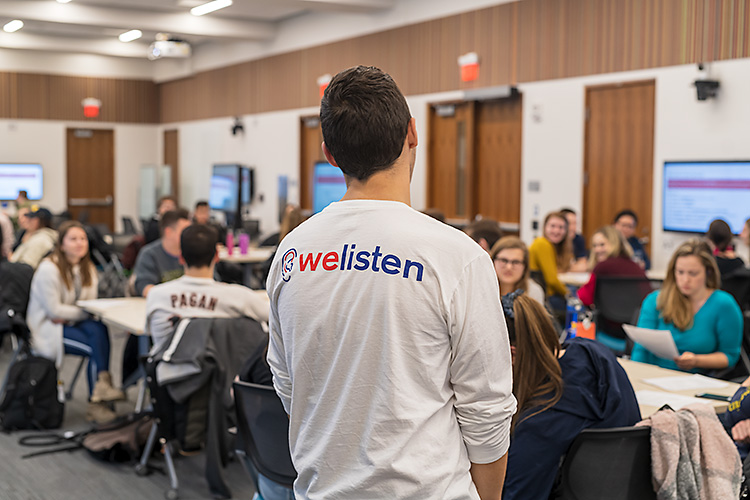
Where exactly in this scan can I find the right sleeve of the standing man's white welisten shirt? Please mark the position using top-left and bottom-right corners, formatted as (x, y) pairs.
(450, 254), (516, 464)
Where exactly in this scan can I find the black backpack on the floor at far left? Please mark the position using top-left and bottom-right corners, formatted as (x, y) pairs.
(0, 342), (65, 431)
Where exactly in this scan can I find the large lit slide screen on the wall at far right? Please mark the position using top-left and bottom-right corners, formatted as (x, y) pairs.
(662, 161), (750, 234)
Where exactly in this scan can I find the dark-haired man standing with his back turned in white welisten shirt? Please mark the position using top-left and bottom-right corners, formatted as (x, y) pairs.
(267, 66), (516, 500)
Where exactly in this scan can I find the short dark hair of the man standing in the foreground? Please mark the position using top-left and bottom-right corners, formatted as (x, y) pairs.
(320, 66), (411, 181)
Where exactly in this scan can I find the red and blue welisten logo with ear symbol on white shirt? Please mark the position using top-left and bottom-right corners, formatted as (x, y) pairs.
(281, 243), (424, 282)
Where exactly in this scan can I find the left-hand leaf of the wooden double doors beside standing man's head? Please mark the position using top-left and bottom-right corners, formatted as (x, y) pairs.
(427, 102), (476, 220)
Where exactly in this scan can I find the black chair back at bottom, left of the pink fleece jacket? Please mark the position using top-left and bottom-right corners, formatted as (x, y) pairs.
(550, 427), (656, 500)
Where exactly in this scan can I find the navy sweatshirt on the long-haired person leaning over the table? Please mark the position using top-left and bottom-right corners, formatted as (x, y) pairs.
(503, 338), (641, 500)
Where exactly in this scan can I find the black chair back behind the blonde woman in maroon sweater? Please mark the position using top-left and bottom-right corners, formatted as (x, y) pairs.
(594, 276), (658, 339)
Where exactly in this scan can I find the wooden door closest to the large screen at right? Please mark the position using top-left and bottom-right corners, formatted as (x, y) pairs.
(583, 80), (654, 256)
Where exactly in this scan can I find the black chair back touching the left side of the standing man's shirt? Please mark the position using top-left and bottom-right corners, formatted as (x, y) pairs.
(234, 382), (297, 488)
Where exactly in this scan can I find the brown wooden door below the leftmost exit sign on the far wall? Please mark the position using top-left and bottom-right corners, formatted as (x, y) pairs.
(67, 128), (115, 231)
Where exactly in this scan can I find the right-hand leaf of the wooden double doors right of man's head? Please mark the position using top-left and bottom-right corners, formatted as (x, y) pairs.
(474, 95), (522, 224)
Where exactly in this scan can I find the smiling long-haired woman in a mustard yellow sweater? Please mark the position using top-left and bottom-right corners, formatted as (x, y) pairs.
(529, 212), (572, 311)
